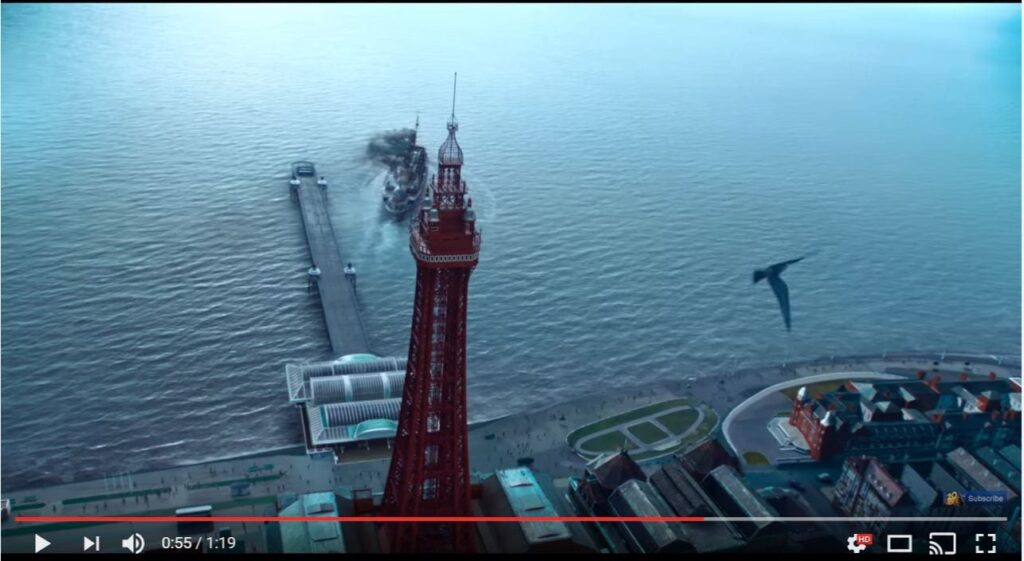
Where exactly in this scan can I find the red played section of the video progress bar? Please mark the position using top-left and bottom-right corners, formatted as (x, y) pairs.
(14, 516), (705, 522)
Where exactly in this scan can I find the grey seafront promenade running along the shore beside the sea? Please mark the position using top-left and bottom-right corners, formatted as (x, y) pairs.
(3, 353), (1021, 552)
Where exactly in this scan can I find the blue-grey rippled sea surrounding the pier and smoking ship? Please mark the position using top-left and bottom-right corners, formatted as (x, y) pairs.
(0, 4), (1021, 490)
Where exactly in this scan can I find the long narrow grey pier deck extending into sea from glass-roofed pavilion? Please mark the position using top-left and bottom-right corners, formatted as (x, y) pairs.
(294, 162), (370, 355)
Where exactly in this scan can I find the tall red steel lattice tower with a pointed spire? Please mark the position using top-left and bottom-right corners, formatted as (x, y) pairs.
(381, 75), (480, 553)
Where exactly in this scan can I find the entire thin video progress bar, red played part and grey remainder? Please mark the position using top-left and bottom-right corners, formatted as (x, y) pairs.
(14, 516), (1007, 523)
